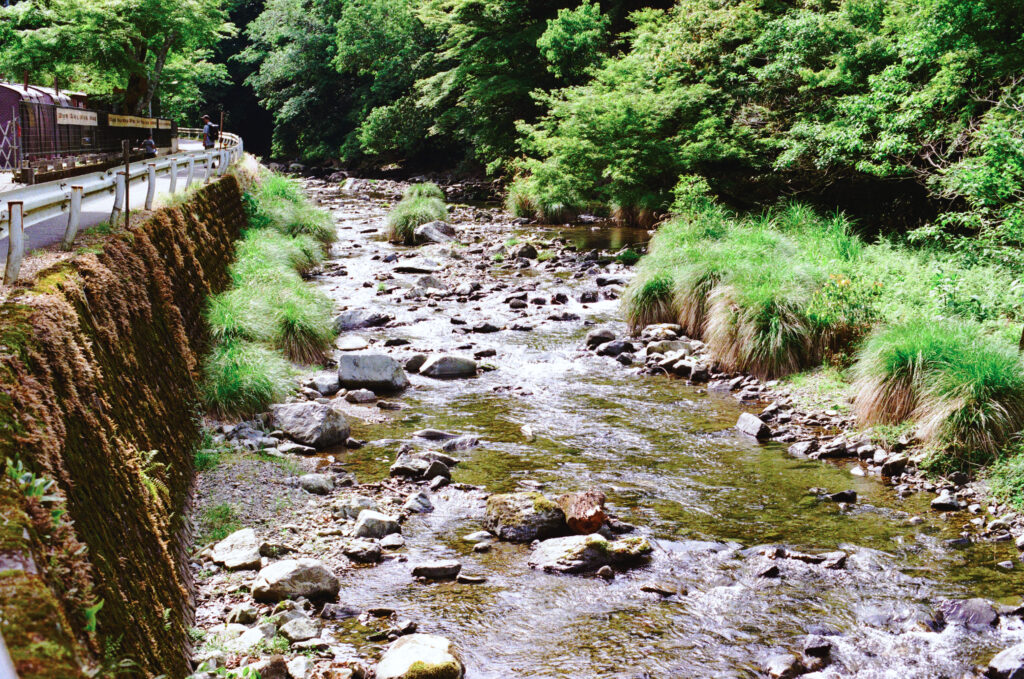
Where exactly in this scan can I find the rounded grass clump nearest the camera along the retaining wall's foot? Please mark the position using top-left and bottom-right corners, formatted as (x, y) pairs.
(203, 339), (293, 417)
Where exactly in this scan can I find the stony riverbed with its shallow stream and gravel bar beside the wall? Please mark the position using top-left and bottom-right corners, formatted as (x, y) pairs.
(194, 180), (1024, 679)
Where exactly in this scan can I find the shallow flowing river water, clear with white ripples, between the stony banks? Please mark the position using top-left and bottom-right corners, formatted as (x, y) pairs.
(307, 182), (1024, 679)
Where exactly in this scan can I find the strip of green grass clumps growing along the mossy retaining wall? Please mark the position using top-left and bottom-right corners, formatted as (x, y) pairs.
(204, 172), (334, 415)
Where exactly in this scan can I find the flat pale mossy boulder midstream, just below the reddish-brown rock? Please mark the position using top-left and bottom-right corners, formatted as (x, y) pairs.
(528, 534), (653, 572)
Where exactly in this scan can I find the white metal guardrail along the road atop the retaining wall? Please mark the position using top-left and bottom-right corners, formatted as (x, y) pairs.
(0, 128), (243, 285)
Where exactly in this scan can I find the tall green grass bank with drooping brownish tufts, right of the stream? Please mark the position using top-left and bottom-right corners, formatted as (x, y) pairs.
(625, 179), (1024, 477)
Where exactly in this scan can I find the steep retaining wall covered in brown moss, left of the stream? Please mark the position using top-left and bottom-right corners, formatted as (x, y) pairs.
(0, 176), (245, 679)
